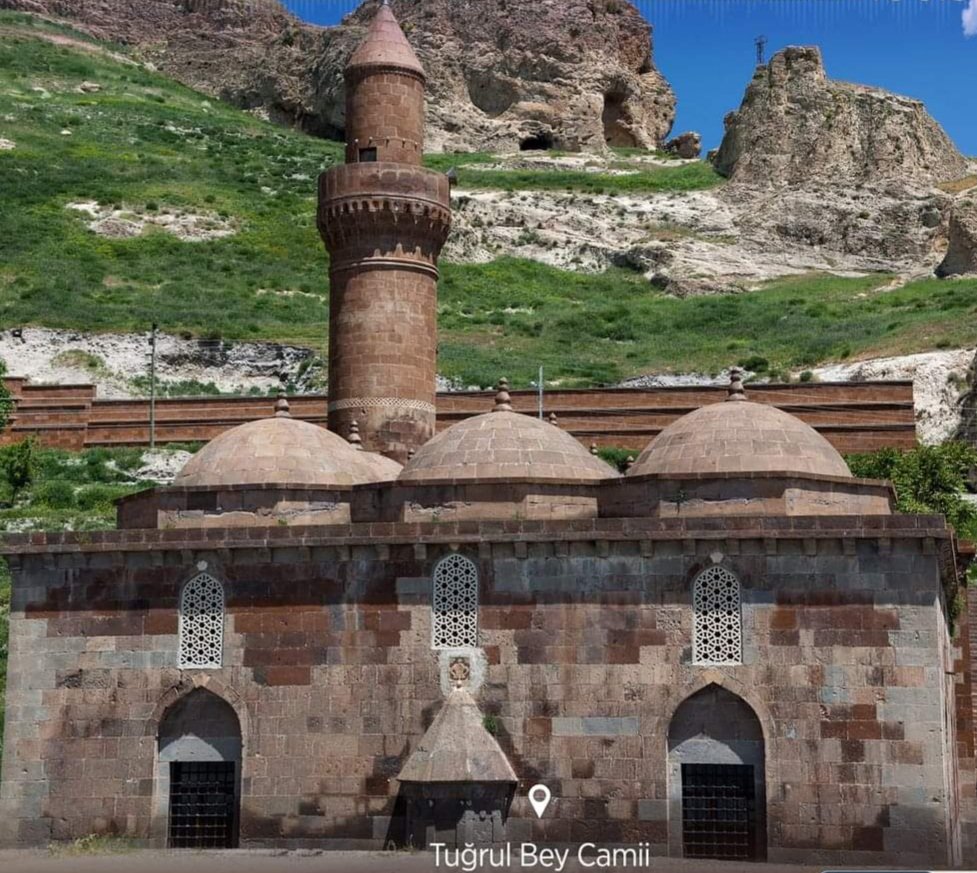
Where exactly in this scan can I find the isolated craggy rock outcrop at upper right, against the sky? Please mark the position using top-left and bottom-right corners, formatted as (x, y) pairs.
(715, 46), (967, 187)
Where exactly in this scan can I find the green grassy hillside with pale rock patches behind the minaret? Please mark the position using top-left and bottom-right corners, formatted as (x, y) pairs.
(0, 10), (977, 433)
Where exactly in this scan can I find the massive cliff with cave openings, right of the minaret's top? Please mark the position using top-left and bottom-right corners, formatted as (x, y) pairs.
(332, 0), (675, 152)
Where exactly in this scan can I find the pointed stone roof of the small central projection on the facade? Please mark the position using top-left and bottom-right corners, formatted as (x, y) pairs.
(397, 688), (518, 782)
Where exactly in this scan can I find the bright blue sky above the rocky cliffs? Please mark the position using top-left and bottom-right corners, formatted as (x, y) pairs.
(283, 0), (977, 156)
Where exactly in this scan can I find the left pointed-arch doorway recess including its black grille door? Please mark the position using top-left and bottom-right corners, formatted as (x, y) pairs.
(157, 688), (241, 849)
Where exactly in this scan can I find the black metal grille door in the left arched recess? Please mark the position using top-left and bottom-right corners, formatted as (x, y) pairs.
(169, 761), (237, 849)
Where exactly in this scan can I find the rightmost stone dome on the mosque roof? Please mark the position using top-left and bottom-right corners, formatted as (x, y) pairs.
(628, 401), (851, 478)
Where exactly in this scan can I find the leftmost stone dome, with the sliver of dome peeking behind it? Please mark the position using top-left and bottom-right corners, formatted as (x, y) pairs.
(173, 416), (400, 487)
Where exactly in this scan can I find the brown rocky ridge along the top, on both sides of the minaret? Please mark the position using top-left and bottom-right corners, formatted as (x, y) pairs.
(0, 0), (675, 152)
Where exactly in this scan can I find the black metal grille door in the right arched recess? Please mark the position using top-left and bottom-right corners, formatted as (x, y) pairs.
(682, 764), (757, 861)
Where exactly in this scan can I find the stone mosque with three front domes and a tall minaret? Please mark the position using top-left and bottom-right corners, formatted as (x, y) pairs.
(0, 6), (977, 867)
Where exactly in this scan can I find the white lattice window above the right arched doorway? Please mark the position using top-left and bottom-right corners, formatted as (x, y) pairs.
(692, 567), (743, 664)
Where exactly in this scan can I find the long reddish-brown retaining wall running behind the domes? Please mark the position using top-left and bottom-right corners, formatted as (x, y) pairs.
(0, 379), (916, 453)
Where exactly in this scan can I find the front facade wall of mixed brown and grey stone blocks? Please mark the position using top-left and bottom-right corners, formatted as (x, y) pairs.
(0, 528), (960, 866)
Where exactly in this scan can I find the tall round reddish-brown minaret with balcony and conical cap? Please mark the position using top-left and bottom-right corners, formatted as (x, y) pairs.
(319, 4), (451, 463)
